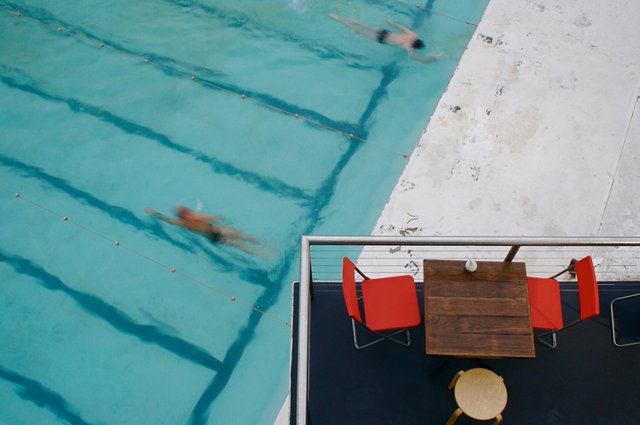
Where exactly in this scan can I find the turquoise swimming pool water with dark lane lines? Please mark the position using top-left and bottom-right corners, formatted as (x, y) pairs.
(0, 0), (486, 424)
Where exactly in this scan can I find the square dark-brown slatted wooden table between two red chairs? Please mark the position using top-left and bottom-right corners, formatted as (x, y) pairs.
(424, 260), (535, 358)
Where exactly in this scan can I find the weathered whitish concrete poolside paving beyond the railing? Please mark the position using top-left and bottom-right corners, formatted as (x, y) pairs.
(373, 0), (640, 240)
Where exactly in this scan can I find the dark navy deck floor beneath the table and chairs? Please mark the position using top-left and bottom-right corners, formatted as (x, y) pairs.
(298, 283), (640, 425)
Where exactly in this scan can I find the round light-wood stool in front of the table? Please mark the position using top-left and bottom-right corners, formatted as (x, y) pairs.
(446, 368), (507, 425)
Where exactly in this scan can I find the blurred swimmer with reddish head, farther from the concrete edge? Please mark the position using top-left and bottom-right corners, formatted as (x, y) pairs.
(145, 205), (262, 256)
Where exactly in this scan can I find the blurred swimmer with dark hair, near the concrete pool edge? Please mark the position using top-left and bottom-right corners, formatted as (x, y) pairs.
(329, 13), (444, 63)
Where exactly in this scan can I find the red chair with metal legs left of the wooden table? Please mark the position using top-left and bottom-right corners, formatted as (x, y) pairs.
(342, 257), (421, 349)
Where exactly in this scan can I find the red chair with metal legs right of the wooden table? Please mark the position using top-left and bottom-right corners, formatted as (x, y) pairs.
(527, 256), (600, 348)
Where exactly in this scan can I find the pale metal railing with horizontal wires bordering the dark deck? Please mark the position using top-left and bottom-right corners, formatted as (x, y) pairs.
(291, 236), (640, 425)
